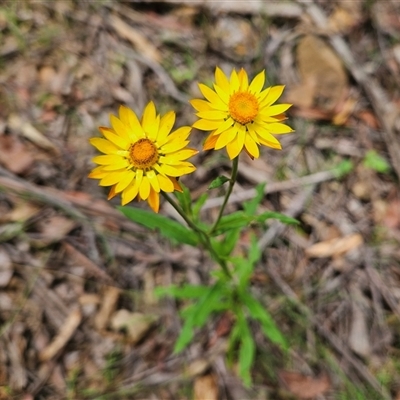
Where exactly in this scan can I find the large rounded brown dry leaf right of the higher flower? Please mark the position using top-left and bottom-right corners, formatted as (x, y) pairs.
(286, 35), (348, 114)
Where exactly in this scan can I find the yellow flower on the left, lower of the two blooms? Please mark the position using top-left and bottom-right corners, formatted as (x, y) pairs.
(89, 102), (198, 212)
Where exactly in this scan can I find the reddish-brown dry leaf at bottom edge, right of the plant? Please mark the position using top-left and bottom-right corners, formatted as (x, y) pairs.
(279, 371), (331, 399)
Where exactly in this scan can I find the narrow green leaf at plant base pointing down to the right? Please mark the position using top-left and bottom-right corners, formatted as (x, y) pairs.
(241, 292), (288, 350)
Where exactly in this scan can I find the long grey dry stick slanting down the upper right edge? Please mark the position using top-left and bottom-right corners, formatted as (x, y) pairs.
(297, 0), (400, 179)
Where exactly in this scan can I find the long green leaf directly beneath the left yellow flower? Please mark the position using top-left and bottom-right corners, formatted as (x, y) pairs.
(118, 206), (199, 246)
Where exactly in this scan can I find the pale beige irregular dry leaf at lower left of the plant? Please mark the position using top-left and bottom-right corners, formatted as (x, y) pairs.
(110, 309), (158, 344)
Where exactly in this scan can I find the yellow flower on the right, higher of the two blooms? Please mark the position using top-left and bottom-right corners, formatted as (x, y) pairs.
(191, 67), (293, 160)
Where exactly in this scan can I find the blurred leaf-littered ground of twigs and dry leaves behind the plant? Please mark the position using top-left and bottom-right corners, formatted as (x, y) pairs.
(0, 0), (400, 400)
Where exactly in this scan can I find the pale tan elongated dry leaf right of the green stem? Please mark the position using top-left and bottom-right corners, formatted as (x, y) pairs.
(305, 233), (364, 258)
